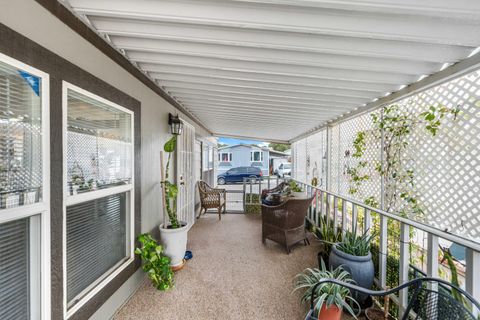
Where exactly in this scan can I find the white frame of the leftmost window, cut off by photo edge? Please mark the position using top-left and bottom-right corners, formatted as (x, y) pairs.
(0, 53), (51, 320)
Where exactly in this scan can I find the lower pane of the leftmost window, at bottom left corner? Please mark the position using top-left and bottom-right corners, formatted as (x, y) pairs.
(0, 219), (30, 320)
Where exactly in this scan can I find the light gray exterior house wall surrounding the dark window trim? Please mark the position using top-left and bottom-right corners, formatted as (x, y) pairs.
(0, 0), (209, 319)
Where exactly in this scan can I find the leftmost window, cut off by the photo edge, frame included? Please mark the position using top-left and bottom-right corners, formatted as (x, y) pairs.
(0, 54), (51, 320)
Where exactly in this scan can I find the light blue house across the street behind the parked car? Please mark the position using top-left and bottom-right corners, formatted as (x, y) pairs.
(218, 144), (270, 175)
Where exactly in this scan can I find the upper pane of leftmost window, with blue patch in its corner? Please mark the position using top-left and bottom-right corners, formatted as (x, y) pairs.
(0, 62), (42, 208)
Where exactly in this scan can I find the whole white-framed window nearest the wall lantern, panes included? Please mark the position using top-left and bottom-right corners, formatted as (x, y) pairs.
(63, 82), (134, 317)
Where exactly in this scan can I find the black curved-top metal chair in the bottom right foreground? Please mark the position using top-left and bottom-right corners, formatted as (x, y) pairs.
(305, 278), (480, 320)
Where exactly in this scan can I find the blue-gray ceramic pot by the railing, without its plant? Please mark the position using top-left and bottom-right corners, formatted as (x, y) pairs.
(328, 244), (375, 304)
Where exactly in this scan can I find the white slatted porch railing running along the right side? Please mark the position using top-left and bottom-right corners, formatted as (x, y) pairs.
(296, 180), (480, 315)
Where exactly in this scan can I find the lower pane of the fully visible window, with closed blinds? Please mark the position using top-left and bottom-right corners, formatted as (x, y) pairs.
(67, 193), (128, 306)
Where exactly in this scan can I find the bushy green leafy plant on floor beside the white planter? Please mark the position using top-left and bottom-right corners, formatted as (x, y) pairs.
(135, 233), (174, 291)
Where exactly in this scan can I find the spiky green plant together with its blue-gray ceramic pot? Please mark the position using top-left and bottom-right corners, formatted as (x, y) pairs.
(329, 230), (375, 304)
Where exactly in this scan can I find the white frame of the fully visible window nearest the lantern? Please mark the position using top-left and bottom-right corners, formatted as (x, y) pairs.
(62, 81), (135, 319)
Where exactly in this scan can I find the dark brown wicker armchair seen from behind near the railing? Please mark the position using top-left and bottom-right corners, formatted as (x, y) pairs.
(262, 197), (313, 253)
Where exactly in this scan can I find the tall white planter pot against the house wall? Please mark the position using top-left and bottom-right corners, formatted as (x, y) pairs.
(160, 221), (188, 267)
